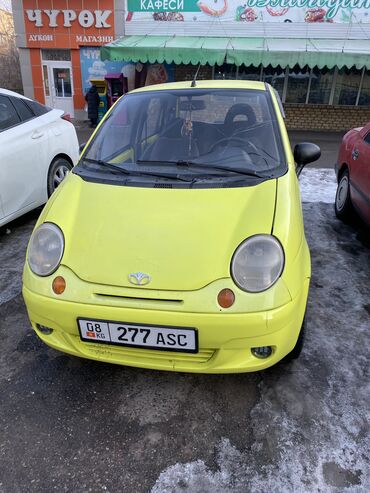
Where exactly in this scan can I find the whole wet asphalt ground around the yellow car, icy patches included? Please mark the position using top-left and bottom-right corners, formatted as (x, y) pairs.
(0, 135), (370, 493)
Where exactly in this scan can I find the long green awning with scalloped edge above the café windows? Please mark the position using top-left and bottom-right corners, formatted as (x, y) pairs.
(100, 36), (370, 69)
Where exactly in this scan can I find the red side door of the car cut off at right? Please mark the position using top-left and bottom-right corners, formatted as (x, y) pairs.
(350, 124), (370, 223)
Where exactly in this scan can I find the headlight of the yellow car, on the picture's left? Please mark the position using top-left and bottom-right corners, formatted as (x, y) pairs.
(28, 223), (64, 276)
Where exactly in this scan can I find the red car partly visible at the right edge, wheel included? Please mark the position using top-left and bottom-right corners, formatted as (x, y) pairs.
(335, 123), (370, 225)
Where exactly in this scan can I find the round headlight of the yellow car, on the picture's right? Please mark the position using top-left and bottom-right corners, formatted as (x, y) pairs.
(231, 235), (284, 293)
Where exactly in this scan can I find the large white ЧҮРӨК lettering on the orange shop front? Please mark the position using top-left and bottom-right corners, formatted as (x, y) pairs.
(26, 9), (112, 29)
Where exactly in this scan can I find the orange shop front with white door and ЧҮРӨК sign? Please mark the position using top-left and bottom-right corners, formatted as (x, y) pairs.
(12, 0), (123, 118)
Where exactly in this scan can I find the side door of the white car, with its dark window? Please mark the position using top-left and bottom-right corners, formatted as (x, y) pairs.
(0, 94), (47, 217)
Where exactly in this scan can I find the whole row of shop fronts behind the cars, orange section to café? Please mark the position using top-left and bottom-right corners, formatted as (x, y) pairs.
(13, 0), (370, 130)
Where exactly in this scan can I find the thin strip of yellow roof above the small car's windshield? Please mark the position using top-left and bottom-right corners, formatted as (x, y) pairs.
(130, 80), (267, 93)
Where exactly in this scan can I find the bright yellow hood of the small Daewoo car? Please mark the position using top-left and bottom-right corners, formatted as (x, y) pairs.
(44, 174), (276, 291)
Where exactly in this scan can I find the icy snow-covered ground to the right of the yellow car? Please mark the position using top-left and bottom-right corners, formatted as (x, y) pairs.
(152, 169), (370, 493)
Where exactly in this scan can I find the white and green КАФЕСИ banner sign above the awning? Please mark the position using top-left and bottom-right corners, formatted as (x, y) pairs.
(126, 0), (370, 23)
